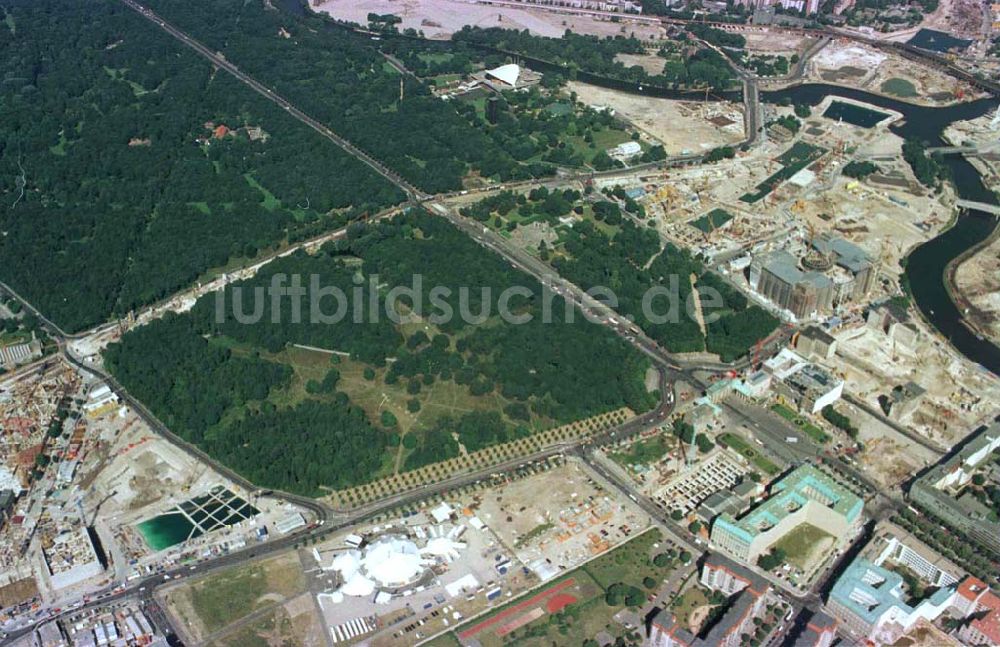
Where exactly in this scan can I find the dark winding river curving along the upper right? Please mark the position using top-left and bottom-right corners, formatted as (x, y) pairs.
(277, 0), (1000, 375)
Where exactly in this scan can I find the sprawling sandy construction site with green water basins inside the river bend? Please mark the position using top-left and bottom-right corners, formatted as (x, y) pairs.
(620, 97), (953, 316)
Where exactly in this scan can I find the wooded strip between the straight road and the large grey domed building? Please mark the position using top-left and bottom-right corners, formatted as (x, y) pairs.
(463, 192), (779, 361)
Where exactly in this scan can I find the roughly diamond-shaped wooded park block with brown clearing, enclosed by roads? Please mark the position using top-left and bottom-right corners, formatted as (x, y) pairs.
(105, 211), (656, 494)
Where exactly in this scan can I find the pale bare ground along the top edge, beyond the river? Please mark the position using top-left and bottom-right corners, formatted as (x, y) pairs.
(312, 0), (666, 40)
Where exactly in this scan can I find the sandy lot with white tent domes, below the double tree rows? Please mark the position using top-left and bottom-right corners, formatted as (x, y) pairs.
(162, 457), (650, 646)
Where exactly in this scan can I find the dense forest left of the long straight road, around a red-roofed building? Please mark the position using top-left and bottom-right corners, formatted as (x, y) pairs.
(0, 1), (402, 330)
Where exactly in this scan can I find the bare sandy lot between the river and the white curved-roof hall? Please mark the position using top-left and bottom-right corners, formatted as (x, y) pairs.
(568, 81), (743, 155)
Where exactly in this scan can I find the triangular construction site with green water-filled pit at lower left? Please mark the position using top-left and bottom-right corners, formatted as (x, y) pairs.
(0, 360), (307, 615)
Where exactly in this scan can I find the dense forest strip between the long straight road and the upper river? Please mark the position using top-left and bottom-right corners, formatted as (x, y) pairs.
(141, 0), (553, 193)
